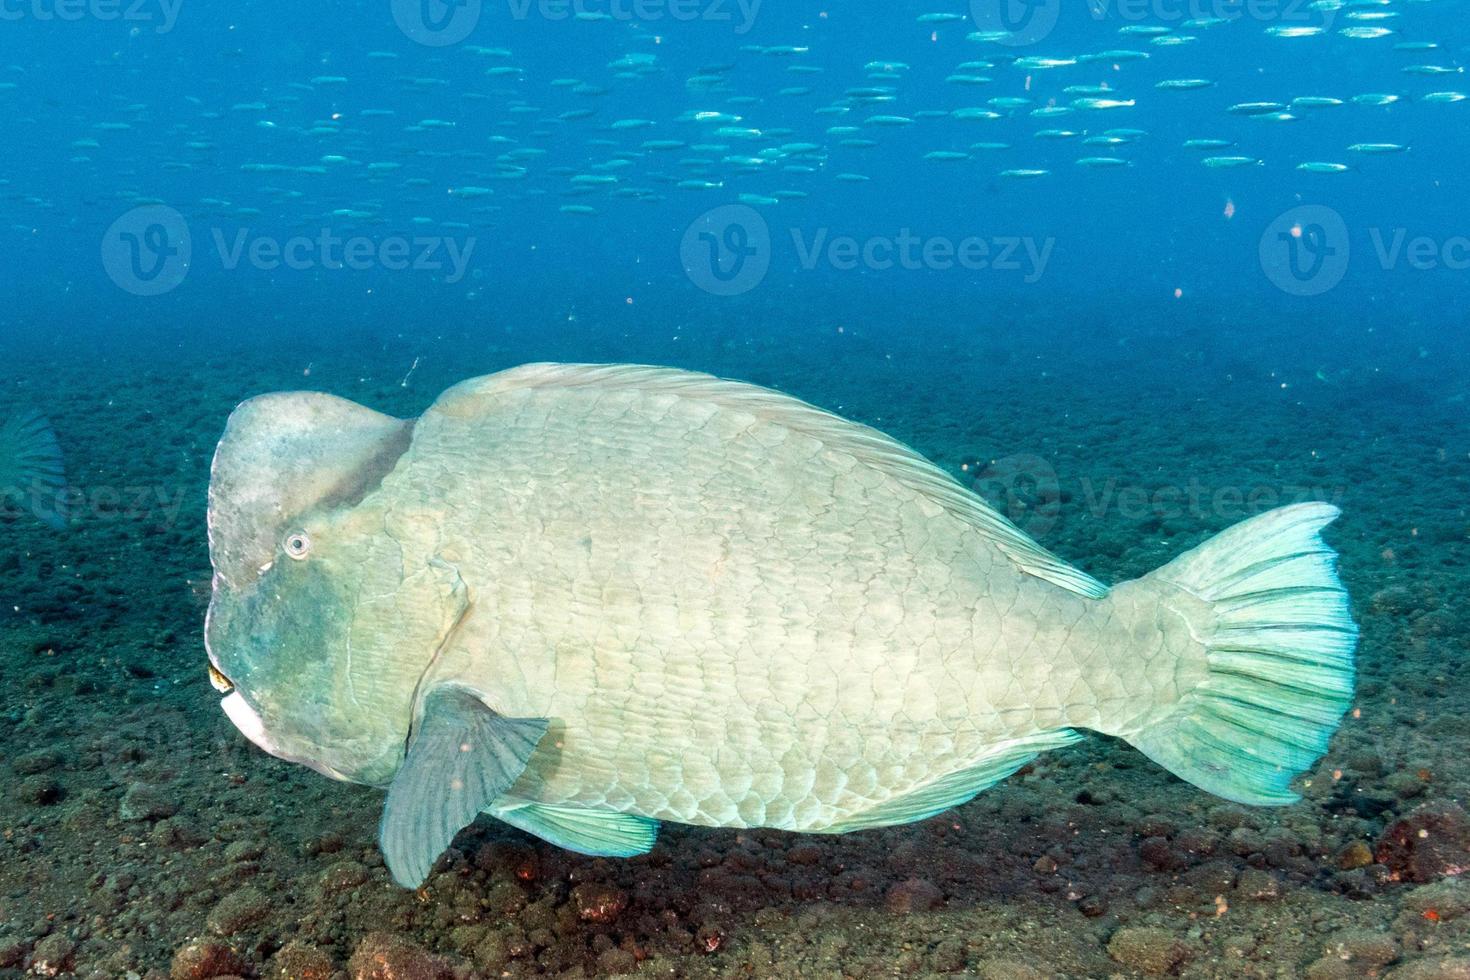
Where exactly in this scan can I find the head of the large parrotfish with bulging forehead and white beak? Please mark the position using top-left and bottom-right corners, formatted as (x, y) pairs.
(204, 394), (465, 785)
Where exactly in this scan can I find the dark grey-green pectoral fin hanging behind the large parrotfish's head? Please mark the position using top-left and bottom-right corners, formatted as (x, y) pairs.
(378, 688), (547, 887)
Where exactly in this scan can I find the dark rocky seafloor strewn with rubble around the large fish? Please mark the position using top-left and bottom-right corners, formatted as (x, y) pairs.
(0, 318), (1470, 980)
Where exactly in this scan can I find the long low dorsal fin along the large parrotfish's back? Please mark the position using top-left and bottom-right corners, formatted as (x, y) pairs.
(432, 364), (1108, 599)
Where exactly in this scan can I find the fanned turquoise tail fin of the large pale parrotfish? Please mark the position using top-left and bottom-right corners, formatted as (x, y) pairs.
(1129, 504), (1358, 805)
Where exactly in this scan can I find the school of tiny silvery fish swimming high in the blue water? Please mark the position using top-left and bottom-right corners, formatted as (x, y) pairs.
(0, 0), (1467, 232)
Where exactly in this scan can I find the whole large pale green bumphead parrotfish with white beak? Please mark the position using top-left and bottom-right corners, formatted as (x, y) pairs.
(206, 364), (1357, 886)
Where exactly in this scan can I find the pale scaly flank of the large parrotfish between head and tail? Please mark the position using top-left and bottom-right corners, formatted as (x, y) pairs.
(385, 371), (1187, 830)
